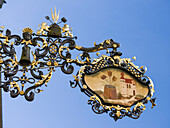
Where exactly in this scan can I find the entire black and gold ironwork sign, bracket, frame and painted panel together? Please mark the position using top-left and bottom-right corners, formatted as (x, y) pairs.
(0, 8), (156, 120)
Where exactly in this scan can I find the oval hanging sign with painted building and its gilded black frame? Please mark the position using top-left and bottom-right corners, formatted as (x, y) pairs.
(67, 46), (156, 121)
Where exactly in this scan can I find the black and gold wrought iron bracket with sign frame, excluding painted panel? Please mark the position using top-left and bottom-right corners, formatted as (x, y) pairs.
(0, 8), (156, 120)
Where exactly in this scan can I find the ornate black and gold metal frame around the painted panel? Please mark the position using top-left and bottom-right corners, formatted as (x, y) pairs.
(71, 55), (156, 121)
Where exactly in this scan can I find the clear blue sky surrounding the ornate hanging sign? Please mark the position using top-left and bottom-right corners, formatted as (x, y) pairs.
(0, 0), (170, 128)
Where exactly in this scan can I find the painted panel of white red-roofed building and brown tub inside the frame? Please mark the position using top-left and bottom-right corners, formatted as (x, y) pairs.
(84, 68), (149, 106)
